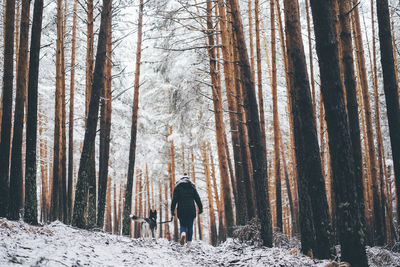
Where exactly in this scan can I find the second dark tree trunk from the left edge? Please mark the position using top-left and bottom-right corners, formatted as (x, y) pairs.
(8, 0), (30, 221)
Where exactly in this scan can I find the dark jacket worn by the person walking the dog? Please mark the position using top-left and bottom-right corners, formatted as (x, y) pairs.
(171, 177), (203, 219)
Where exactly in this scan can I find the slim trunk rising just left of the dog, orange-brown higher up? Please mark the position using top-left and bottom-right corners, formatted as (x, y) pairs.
(122, 0), (143, 235)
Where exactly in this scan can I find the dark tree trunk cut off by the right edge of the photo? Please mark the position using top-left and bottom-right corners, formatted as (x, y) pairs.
(376, 0), (400, 228)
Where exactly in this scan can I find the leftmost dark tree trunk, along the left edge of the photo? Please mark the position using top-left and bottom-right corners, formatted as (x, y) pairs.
(0, 0), (15, 217)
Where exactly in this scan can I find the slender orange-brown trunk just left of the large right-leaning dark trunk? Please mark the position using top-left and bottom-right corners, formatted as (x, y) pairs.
(66, 0), (78, 226)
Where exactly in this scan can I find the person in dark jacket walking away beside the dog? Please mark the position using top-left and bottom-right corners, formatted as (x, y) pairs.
(171, 173), (203, 247)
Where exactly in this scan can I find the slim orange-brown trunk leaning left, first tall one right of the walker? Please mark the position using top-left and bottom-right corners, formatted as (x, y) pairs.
(207, 1), (234, 236)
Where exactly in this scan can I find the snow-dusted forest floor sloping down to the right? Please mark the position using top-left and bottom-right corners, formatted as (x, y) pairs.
(0, 218), (400, 267)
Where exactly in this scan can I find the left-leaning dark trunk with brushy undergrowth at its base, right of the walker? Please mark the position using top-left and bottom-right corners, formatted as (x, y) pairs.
(229, 0), (272, 247)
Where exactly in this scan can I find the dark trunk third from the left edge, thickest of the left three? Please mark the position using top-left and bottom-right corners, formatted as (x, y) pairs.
(24, 0), (46, 224)
